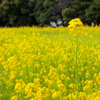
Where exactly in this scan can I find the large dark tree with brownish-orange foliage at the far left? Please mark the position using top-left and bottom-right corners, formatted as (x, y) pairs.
(0, 0), (35, 26)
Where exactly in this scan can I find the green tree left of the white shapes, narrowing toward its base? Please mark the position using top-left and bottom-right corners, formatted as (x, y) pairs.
(34, 0), (58, 26)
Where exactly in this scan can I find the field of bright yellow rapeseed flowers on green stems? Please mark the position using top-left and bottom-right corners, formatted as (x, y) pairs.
(0, 21), (100, 100)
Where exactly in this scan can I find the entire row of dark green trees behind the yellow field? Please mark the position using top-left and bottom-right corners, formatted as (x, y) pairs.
(0, 0), (100, 26)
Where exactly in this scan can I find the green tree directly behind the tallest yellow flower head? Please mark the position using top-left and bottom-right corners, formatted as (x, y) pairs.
(62, 0), (92, 25)
